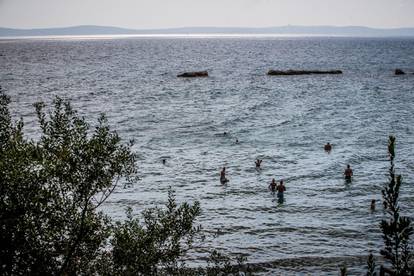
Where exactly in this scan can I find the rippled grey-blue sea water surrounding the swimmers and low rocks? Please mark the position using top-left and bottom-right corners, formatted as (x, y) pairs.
(0, 37), (414, 274)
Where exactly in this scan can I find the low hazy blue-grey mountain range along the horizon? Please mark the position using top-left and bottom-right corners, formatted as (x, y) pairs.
(0, 25), (414, 37)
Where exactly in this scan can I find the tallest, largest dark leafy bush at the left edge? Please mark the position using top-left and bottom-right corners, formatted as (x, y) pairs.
(0, 89), (136, 274)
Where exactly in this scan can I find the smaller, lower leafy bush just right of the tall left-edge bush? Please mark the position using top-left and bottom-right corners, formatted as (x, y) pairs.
(111, 191), (200, 275)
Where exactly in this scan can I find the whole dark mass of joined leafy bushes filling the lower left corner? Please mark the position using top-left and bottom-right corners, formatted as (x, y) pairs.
(0, 88), (246, 275)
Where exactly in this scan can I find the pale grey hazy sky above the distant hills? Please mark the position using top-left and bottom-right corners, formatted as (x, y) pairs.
(0, 0), (414, 29)
